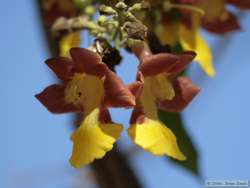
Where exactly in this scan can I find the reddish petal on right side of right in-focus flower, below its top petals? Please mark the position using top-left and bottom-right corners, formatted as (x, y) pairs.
(158, 77), (200, 112)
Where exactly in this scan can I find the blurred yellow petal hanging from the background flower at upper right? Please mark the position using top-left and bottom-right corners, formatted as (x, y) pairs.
(180, 26), (215, 77)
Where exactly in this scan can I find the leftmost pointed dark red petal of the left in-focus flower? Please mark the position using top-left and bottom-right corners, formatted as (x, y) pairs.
(35, 84), (80, 114)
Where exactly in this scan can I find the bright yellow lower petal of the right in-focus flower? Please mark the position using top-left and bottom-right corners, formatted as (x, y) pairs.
(128, 118), (186, 160)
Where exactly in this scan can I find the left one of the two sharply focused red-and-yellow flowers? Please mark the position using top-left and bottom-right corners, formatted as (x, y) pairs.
(36, 48), (135, 167)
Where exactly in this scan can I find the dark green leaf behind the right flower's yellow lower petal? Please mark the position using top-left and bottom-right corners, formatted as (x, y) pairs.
(158, 110), (201, 178)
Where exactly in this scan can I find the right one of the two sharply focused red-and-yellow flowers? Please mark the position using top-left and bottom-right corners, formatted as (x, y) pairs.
(128, 42), (199, 160)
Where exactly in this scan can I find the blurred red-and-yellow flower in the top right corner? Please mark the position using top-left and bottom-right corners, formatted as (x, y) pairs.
(156, 0), (250, 77)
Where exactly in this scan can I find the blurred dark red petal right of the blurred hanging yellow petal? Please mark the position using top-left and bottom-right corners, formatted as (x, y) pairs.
(202, 12), (241, 35)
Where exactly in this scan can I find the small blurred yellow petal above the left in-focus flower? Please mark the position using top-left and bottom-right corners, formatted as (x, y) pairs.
(59, 31), (81, 57)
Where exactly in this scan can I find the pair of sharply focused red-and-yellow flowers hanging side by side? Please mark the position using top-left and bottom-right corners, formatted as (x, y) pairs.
(36, 43), (199, 167)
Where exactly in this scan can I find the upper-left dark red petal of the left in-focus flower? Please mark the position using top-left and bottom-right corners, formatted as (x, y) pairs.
(45, 57), (74, 82)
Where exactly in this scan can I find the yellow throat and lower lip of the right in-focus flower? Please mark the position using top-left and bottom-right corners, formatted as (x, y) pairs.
(128, 74), (186, 160)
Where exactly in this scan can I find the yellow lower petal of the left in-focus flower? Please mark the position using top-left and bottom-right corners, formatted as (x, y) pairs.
(70, 109), (123, 168)
